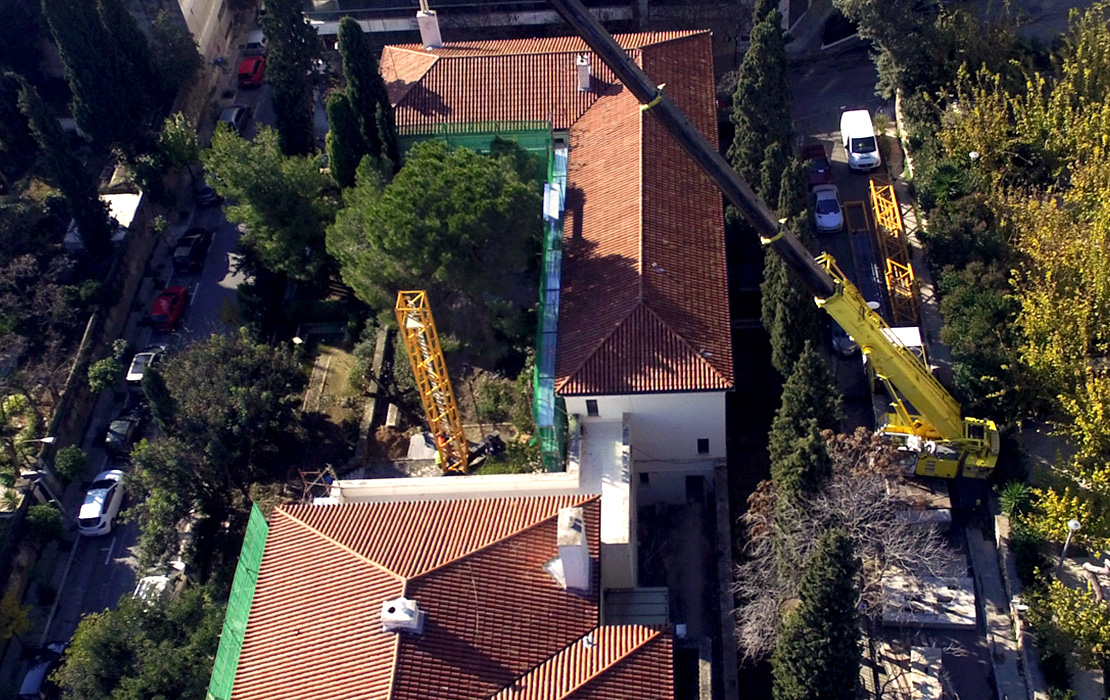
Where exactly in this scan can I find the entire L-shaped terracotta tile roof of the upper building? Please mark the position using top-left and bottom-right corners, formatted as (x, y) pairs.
(382, 31), (733, 395)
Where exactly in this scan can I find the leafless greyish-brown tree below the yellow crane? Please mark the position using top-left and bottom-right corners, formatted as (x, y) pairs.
(733, 428), (951, 659)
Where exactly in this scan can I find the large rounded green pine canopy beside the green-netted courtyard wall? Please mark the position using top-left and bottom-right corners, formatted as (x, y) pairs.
(327, 141), (542, 363)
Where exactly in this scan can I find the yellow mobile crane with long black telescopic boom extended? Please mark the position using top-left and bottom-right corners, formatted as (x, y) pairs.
(551, 0), (999, 478)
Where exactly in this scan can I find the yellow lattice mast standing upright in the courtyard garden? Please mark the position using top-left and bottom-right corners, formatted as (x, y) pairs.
(394, 290), (471, 471)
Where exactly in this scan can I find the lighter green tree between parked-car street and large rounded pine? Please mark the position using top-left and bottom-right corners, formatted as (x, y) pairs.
(201, 128), (337, 280)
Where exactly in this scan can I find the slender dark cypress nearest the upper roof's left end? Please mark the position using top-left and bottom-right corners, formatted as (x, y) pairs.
(339, 17), (401, 174)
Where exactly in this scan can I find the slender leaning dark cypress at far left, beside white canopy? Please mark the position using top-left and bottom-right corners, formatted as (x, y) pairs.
(14, 73), (112, 257)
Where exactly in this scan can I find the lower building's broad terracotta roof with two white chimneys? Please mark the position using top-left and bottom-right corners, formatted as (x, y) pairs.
(232, 496), (670, 700)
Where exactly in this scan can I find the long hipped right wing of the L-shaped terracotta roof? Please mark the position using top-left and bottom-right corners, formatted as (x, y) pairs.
(555, 32), (733, 395)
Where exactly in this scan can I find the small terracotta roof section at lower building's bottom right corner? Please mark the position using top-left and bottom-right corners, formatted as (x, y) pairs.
(491, 625), (674, 700)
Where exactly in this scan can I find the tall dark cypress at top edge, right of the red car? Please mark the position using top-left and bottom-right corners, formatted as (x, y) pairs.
(262, 0), (320, 155)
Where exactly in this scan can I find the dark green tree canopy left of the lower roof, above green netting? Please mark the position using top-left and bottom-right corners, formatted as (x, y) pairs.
(128, 334), (306, 564)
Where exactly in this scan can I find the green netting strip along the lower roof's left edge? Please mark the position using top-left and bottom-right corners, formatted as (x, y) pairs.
(206, 506), (270, 700)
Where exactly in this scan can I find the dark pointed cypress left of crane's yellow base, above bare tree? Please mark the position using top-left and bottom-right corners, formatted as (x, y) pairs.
(767, 342), (840, 470)
